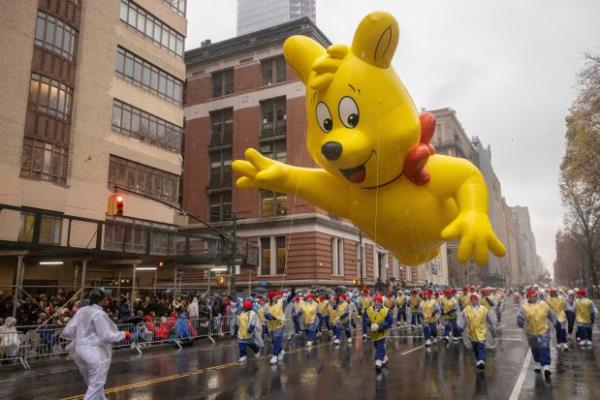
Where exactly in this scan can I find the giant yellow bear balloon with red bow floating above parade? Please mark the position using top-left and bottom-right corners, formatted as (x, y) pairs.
(233, 12), (506, 266)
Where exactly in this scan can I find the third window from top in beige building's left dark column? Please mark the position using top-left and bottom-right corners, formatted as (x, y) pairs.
(21, 138), (68, 185)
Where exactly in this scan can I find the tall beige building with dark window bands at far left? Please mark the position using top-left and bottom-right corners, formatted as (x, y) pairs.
(0, 0), (187, 304)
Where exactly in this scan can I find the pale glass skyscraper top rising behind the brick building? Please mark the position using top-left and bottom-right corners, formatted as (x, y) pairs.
(237, 0), (316, 36)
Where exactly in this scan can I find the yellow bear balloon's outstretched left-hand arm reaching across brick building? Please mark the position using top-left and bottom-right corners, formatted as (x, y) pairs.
(232, 149), (350, 217)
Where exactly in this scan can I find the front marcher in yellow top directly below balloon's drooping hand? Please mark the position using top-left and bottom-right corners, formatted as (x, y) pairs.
(458, 293), (495, 370)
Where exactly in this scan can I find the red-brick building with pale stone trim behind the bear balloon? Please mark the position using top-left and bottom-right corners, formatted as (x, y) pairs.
(183, 18), (417, 286)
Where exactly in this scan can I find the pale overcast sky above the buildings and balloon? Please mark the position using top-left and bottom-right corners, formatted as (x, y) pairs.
(186, 0), (600, 276)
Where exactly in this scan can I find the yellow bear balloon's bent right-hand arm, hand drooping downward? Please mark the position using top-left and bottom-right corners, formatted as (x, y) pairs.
(427, 155), (506, 266)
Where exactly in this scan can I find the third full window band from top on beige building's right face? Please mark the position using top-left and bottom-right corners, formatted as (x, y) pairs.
(112, 99), (183, 153)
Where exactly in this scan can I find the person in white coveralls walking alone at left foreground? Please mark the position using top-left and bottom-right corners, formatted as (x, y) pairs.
(61, 289), (131, 400)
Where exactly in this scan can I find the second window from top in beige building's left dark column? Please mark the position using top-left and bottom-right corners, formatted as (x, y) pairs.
(29, 73), (73, 121)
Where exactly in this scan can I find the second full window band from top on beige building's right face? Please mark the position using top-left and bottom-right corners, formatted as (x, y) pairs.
(116, 47), (183, 105)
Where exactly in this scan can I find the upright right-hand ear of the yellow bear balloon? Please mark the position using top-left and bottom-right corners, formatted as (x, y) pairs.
(352, 11), (400, 68)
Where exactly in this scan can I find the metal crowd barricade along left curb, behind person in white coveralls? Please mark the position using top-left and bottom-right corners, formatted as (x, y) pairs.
(0, 316), (230, 369)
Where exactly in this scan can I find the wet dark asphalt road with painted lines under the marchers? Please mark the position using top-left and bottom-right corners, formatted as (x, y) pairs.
(0, 305), (600, 400)
